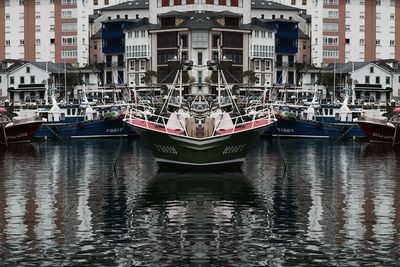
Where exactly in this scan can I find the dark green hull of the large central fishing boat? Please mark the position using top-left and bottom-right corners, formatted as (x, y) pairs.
(128, 123), (273, 169)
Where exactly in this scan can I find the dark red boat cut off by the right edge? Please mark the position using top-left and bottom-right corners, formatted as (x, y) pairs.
(356, 107), (400, 145)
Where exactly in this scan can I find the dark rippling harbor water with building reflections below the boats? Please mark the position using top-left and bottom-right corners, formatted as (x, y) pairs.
(0, 139), (400, 266)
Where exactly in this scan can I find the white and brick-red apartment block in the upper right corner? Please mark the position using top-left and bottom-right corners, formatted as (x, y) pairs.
(274, 0), (400, 66)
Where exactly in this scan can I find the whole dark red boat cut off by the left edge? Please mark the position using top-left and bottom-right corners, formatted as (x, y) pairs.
(0, 107), (44, 145)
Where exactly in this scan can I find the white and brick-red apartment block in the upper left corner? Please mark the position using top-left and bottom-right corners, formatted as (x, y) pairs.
(0, 0), (126, 66)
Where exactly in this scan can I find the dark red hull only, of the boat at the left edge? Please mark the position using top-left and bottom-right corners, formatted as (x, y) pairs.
(0, 121), (43, 144)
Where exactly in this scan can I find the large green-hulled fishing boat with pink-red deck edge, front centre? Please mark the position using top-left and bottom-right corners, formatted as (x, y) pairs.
(125, 57), (275, 170)
